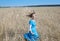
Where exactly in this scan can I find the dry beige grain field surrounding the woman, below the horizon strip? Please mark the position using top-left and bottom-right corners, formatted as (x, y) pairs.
(0, 7), (60, 41)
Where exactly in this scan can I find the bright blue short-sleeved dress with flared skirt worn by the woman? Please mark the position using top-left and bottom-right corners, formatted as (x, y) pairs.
(24, 19), (39, 41)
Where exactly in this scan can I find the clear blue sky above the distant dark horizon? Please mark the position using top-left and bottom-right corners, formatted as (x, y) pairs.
(0, 0), (60, 6)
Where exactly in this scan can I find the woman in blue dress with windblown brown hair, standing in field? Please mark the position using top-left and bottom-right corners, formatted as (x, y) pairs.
(24, 11), (39, 41)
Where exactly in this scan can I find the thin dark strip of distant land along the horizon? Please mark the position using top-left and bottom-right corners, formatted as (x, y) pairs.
(0, 4), (60, 8)
